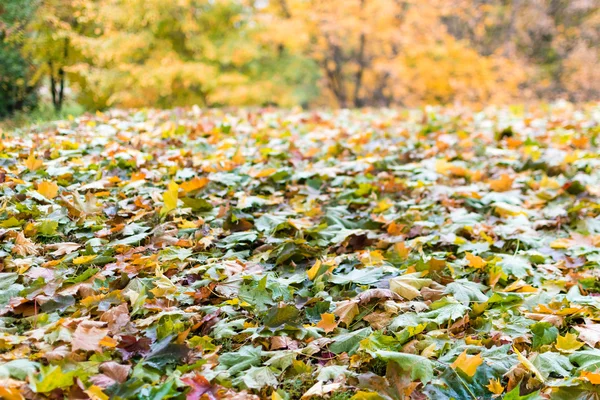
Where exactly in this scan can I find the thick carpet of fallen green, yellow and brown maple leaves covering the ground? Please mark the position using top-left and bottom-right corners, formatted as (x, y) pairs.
(0, 104), (600, 400)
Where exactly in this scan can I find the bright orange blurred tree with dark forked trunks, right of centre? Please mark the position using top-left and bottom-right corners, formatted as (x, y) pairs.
(261, 0), (524, 107)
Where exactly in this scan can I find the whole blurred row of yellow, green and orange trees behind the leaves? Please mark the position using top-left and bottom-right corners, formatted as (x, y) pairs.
(0, 0), (600, 116)
